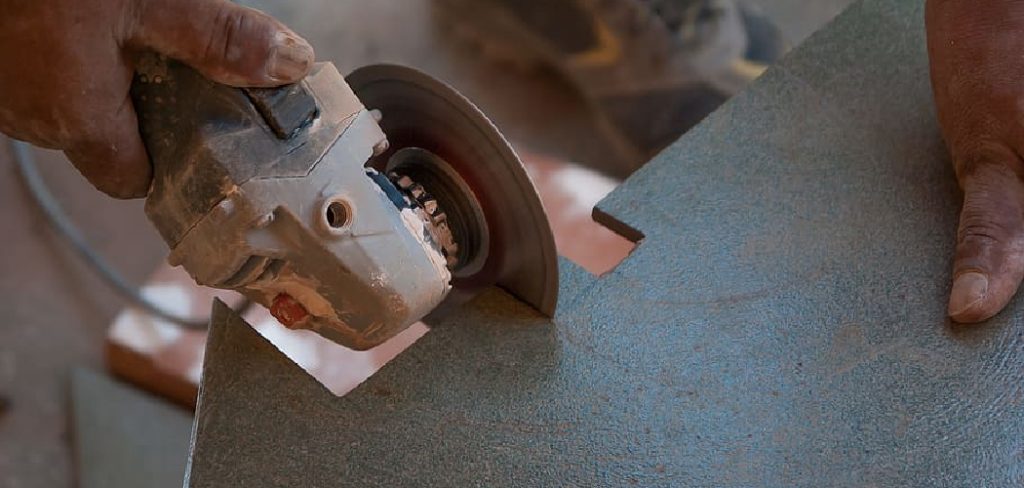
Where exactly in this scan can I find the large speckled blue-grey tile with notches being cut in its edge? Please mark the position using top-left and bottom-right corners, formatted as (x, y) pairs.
(184, 0), (1024, 487)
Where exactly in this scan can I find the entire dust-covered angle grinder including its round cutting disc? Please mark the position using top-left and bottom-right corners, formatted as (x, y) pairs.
(132, 55), (558, 350)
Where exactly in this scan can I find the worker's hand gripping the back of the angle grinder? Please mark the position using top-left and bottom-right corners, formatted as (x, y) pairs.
(0, 0), (313, 197)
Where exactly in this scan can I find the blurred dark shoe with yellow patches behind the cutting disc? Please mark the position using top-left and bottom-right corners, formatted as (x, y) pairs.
(435, 0), (786, 177)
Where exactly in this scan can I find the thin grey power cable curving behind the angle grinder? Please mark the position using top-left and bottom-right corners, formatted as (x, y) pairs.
(9, 139), (252, 329)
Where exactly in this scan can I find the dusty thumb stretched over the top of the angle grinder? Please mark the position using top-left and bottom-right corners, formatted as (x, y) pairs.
(127, 0), (313, 87)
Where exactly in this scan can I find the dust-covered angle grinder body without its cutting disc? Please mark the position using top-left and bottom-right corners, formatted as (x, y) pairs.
(132, 55), (452, 350)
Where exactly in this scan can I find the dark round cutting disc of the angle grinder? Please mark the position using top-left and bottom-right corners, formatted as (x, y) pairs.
(346, 64), (558, 316)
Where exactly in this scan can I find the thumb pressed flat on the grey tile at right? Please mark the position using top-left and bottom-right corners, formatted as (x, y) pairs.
(949, 162), (1024, 322)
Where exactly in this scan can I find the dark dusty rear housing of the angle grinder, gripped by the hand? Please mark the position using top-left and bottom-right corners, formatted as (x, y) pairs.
(131, 53), (317, 249)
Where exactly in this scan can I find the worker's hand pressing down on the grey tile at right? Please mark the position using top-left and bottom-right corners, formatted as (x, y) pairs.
(927, 0), (1024, 322)
